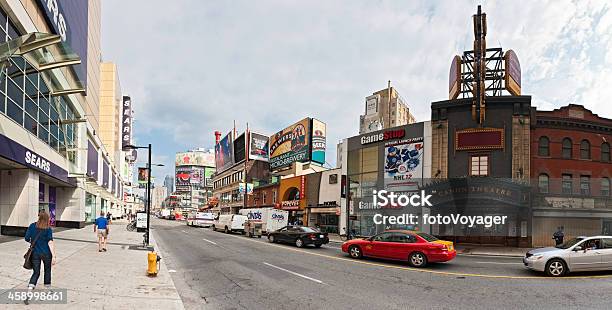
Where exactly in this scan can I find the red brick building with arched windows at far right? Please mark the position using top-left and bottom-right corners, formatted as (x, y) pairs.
(531, 104), (612, 246)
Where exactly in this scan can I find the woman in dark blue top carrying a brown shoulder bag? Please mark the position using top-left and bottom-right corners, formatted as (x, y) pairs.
(24, 211), (55, 289)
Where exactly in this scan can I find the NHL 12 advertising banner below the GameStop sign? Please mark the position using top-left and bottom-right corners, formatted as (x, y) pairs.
(384, 139), (423, 191)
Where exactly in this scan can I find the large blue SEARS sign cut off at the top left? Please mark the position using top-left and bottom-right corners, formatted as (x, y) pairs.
(37, 0), (89, 88)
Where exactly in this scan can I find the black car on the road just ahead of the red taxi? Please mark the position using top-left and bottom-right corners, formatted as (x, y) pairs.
(268, 226), (329, 248)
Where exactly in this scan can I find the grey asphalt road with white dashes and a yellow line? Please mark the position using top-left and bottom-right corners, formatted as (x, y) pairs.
(152, 219), (612, 309)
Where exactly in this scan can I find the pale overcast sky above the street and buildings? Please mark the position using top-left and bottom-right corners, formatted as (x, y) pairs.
(102, 0), (612, 182)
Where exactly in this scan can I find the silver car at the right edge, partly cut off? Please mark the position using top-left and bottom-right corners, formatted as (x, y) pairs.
(523, 236), (612, 277)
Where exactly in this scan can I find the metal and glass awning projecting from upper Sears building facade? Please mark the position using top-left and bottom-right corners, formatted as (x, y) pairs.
(0, 32), (85, 96)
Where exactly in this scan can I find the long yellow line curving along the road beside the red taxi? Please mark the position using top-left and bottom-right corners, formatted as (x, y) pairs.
(216, 231), (612, 280)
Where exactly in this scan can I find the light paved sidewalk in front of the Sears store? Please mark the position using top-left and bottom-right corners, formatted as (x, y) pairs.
(0, 220), (183, 309)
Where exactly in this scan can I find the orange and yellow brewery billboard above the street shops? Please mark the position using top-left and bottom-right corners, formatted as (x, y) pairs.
(269, 118), (310, 169)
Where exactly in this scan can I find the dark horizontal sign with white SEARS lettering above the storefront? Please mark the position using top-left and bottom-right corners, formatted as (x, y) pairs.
(0, 135), (71, 183)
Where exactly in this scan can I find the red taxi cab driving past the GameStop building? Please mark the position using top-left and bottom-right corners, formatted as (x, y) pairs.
(342, 230), (457, 267)
